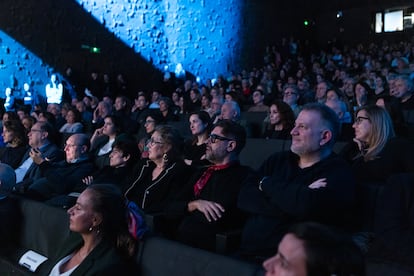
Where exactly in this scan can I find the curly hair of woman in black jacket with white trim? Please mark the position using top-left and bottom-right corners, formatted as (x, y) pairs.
(154, 125), (184, 163)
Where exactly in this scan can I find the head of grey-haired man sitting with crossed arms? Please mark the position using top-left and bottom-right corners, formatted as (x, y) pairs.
(290, 103), (340, 161)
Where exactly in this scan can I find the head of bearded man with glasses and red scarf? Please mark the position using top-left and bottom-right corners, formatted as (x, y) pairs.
(206, 120), (246, 165)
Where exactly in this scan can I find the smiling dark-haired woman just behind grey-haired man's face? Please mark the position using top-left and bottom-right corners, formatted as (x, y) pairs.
(263, 100), (295, 140)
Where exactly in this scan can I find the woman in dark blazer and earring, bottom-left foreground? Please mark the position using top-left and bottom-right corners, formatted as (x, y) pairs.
(49, 184), (135, 276)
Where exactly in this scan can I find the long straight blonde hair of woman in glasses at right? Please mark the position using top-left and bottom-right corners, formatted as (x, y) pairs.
(357, 105), (395, 161)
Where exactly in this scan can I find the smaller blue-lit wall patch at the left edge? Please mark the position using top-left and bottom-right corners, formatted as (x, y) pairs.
(0, 30), (61, 99)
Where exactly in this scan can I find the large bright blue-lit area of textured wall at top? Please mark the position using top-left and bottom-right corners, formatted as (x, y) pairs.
(75, 0), (243, 80)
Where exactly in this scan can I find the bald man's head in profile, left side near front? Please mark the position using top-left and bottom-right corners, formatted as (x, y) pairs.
(64, 133), (90, 163)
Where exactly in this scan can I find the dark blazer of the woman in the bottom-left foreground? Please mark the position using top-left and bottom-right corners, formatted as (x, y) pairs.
(50, 233), (136, 276)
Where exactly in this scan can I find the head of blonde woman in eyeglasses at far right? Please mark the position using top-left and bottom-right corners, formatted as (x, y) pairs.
(353, 105), (395, 160)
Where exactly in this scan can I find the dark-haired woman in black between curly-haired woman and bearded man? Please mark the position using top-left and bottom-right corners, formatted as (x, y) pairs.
(184, 111), (211, 167)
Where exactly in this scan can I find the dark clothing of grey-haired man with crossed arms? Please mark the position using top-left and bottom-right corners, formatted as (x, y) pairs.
(238, 152), (355, 257)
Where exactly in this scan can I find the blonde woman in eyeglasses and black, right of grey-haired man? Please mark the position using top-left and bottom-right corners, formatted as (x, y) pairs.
(341, 105), (414, 233)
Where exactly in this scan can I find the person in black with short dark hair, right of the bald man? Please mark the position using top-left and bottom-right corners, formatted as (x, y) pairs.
(82, 139), (139, 192)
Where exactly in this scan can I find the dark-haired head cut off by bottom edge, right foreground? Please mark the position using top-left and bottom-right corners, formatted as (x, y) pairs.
(263, 223), (365, 276)
